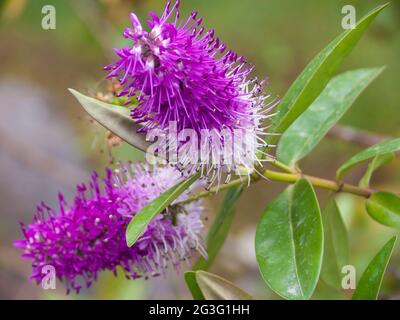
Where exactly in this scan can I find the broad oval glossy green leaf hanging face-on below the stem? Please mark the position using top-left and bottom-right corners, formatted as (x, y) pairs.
(255, 179), (324, 299)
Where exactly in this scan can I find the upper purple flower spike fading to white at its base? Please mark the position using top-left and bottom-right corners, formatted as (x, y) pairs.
(105, 1), (278, 182)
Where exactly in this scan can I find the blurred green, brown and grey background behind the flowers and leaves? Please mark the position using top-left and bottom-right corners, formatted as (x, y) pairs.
(0, 0), (400, 299)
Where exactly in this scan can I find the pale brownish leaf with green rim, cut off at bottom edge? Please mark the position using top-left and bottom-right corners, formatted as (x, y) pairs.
(194, 271), (253, 300)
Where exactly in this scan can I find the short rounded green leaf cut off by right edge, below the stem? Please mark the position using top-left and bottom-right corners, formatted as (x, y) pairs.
(365, 192), (400, 228)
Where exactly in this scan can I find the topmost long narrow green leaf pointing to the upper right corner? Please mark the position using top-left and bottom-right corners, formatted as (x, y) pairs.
(271, 4), (387, 143)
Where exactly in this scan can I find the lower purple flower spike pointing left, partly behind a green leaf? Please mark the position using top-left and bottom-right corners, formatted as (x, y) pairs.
(15, 165), (206, 292)
